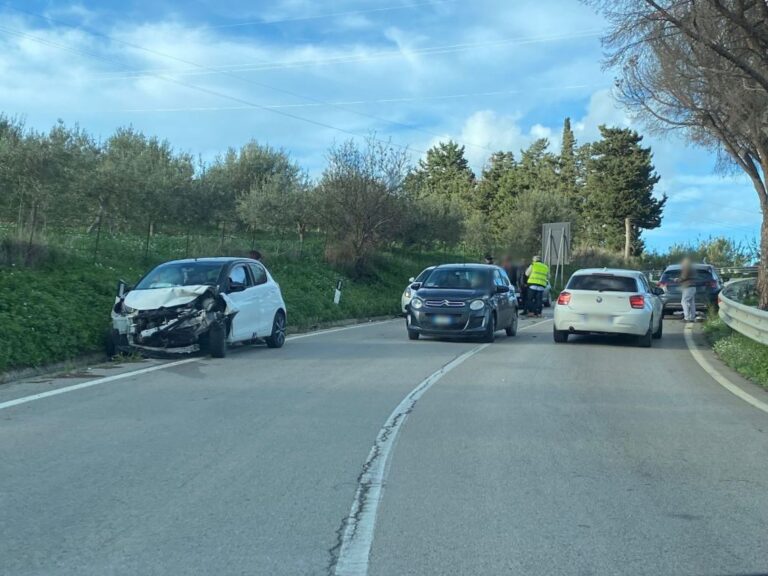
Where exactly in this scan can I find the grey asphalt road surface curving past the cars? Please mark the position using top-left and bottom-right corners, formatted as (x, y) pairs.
(0, 321), (768, 576)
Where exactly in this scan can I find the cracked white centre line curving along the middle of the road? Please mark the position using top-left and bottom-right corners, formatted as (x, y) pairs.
(334, 320), (551, 576)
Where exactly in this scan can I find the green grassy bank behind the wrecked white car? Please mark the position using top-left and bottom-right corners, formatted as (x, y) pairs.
(0, 235), (459, 371)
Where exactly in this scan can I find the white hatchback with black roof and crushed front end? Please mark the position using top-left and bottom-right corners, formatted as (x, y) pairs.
(109, 258), (286, 358)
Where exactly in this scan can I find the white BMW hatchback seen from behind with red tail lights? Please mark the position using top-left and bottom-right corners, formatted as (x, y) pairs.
(554, 268), (663, 348)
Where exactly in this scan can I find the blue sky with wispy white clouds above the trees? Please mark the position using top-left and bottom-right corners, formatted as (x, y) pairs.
(0, 0), (760, 250)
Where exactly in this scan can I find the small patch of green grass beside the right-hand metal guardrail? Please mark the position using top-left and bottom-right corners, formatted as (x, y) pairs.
(704, 314), (768, 388)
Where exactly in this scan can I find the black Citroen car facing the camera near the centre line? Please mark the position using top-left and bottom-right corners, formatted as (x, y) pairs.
(406, 264), (517, 342)
